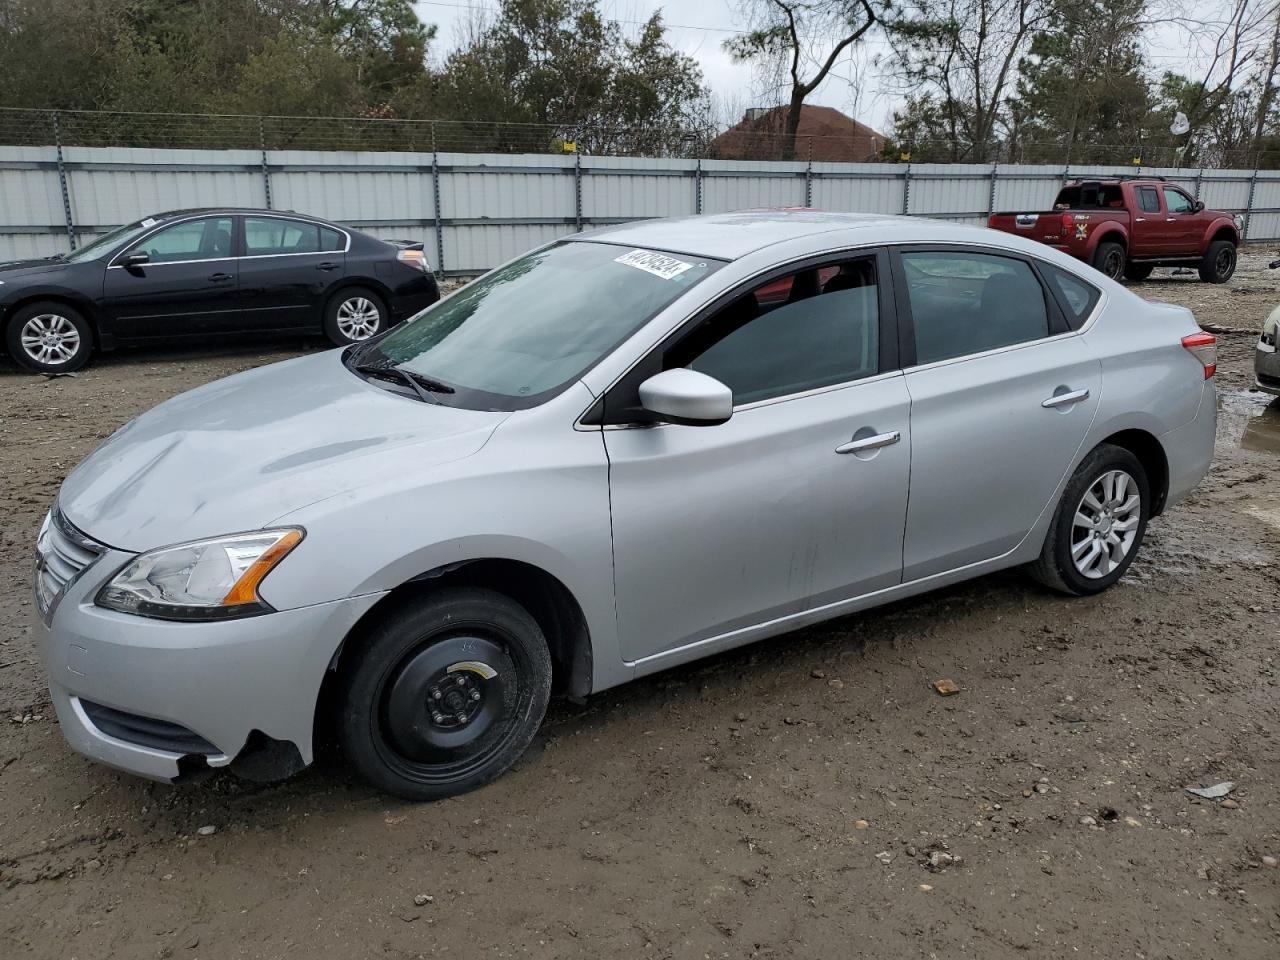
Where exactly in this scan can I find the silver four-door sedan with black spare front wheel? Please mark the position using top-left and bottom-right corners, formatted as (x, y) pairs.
(35, 211), (1216, 799)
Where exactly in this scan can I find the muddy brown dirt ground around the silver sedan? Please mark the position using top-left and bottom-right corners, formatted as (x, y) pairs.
(0, 250), (1280, 960)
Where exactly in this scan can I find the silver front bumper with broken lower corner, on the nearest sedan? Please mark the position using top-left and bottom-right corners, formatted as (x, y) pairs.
(33, 550), (381, 780)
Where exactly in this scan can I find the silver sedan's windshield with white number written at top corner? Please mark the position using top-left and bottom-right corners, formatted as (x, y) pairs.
(349, 242), (723, 410)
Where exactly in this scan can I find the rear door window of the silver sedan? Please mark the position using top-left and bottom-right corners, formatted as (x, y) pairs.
(902, 251), (1048, 364)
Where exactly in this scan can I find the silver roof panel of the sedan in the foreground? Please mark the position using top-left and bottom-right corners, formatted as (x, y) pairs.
(573, 207), (1044, 260)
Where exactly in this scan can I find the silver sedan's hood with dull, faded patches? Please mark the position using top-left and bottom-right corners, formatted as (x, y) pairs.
(58, 351), (508, 552)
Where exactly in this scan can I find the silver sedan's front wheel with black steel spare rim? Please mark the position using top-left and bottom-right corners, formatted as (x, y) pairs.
(338, 588), (552, 800)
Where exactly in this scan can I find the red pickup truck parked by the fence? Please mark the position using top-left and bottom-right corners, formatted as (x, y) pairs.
(987, 177), (1242, 283)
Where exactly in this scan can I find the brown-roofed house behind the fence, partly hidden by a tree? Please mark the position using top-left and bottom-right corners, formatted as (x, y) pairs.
(708, 105), (884, 163)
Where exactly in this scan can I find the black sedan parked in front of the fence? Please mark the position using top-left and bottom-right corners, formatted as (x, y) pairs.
(0, 209), (440, 372)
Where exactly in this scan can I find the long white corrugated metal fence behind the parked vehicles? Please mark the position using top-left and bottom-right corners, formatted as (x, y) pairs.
(0, 136), (1280, 275)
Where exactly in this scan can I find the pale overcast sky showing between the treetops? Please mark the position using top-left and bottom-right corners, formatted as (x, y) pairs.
(415, 0), (1244, 132)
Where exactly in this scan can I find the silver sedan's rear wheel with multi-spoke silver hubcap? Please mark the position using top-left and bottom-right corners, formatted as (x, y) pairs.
(1029, 443), (1151, 596)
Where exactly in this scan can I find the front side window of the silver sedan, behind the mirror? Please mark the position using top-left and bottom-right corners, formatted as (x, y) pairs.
(664, 257), (879, 403)
